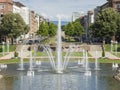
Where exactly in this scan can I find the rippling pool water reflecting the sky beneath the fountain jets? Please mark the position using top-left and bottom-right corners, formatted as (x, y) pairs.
(0, 62), (120, 90)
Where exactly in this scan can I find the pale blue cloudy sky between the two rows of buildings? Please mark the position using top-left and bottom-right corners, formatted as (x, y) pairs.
(14, 0), (107, 20)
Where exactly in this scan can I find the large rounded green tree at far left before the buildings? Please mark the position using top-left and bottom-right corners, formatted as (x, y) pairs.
(0, 13), (29, 44)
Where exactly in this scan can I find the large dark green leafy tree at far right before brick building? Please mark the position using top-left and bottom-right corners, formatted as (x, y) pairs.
(90, 8), (120, 40)
